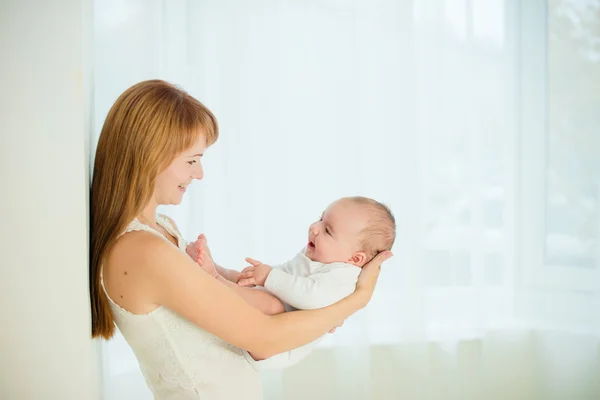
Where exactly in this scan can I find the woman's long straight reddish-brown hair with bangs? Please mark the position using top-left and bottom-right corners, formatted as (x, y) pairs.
(90, 80), (219, 339)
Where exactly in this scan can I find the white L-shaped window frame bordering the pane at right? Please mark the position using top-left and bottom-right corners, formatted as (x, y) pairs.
(508, 0), (600, 292)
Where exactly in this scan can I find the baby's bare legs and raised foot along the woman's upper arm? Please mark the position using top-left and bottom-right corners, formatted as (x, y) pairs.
(186, 235), (285, 315)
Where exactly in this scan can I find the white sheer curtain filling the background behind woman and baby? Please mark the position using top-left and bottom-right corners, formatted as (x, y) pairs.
(95, 0), (600, 400)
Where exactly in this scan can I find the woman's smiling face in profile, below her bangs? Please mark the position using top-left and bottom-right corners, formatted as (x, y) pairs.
(154, 136), (206, 205)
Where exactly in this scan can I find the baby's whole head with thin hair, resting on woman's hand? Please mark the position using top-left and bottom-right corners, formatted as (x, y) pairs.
(305, 197), (396, 267)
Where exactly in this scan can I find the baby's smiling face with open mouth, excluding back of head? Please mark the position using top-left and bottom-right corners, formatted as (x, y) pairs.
(305, 200), (367, 266)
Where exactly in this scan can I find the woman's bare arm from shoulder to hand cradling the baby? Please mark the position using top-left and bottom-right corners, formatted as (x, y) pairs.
(128, 232), (391, 358)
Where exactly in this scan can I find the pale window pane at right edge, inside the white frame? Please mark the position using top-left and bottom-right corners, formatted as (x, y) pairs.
(546, 0), (600, 268)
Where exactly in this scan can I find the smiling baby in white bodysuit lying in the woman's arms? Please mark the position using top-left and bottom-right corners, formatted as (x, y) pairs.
(188, 197), (396, 369)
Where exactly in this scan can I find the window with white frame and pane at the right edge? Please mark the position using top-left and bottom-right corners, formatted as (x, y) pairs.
(520, 0), (600, 291)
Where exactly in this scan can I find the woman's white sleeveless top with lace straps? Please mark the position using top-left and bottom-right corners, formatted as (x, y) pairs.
(101, 216), (263, 400)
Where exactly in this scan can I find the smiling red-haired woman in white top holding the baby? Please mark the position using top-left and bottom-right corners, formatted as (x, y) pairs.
(90, 80), (391, 400)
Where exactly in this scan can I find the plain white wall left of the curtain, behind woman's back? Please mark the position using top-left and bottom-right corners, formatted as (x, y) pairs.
(0, 0), (99, 400)
